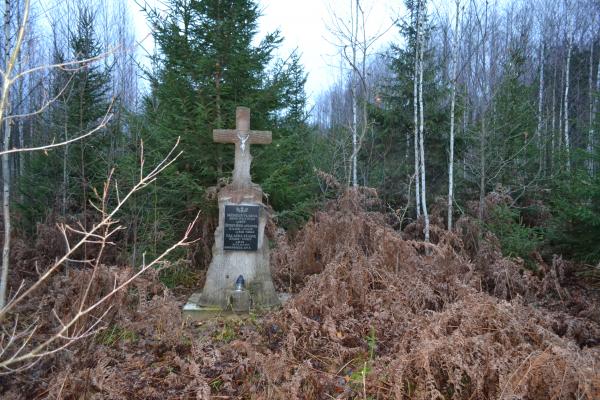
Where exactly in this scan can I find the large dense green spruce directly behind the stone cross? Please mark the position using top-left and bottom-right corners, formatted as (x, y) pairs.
(143, 0), (312, 258)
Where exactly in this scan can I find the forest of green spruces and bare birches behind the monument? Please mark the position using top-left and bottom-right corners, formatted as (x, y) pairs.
(0, 0), (600, 304)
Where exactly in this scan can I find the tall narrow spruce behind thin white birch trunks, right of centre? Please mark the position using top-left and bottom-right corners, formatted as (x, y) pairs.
(374, 0), (449, 211)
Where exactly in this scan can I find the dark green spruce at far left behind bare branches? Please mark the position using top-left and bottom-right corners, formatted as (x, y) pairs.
(20, 7), (111, 226)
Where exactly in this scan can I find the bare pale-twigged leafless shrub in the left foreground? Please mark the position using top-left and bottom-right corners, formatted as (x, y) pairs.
(0, 138), (202, 373)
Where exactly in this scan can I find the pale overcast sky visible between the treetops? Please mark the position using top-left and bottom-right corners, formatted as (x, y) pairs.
(131, 0), (403, 101)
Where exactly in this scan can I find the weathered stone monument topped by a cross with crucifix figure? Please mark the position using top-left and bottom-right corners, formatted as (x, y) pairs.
(183, 107), (280, 318)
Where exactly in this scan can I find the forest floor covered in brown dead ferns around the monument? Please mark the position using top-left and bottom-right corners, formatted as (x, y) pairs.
(0, 191), (600, 400)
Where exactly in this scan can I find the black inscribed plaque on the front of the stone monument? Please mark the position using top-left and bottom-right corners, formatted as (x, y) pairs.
(223, 204), (260, 251)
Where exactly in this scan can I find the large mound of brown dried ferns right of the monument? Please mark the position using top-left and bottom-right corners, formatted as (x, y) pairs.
(267, 193), (600, 399)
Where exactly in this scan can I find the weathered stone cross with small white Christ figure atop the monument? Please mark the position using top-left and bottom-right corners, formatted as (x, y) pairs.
(213, 107), (272, 186)
